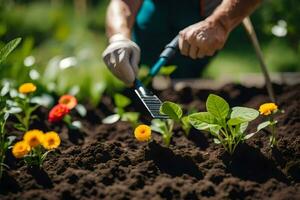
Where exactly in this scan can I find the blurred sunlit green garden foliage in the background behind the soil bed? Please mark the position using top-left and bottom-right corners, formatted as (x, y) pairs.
(0, 0), (300, 104)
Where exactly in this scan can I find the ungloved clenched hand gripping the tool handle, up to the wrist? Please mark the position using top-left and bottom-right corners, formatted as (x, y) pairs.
(179, 20), (229, 59)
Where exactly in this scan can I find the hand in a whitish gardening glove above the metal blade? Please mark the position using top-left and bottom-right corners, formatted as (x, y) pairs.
(102, 34), (140, 86)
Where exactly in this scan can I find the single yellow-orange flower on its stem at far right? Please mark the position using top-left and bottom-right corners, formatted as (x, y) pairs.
(259, 103), (279, 148)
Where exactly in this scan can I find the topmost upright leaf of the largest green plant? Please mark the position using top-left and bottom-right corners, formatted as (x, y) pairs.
(206, 94), (229, 119)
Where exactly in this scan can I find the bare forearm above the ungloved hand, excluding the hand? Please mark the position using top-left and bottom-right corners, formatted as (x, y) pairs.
(207, 0), (262, 32)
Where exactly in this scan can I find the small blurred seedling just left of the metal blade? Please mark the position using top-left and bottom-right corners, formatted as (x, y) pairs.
(102, 94), (140, 127)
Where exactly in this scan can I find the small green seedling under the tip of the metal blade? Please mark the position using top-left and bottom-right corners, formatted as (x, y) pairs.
(151, 101), (191, 146)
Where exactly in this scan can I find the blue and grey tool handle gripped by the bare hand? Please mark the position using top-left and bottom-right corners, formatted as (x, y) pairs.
(149, 35), (179, 77)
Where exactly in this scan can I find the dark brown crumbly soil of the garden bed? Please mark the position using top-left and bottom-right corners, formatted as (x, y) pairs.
(0, 84), (300, 200)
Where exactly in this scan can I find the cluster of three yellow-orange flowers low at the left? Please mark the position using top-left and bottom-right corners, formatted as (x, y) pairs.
(12, 130), (60, 168)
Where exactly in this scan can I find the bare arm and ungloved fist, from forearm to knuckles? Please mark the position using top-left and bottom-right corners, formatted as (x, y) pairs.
(179, 0), (262, 59)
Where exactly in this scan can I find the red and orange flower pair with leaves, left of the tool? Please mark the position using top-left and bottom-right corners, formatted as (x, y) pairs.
(48, 94), (85, 129)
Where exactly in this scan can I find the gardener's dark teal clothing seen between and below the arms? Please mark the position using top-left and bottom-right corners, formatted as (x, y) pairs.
(133, 0), (212, 78)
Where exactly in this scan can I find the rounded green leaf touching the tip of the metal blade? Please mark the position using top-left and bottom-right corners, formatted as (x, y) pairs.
(160, 101), (182, 122)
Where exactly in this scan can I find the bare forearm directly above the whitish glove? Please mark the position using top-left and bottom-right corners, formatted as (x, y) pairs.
(106, 0), (142, 38)
